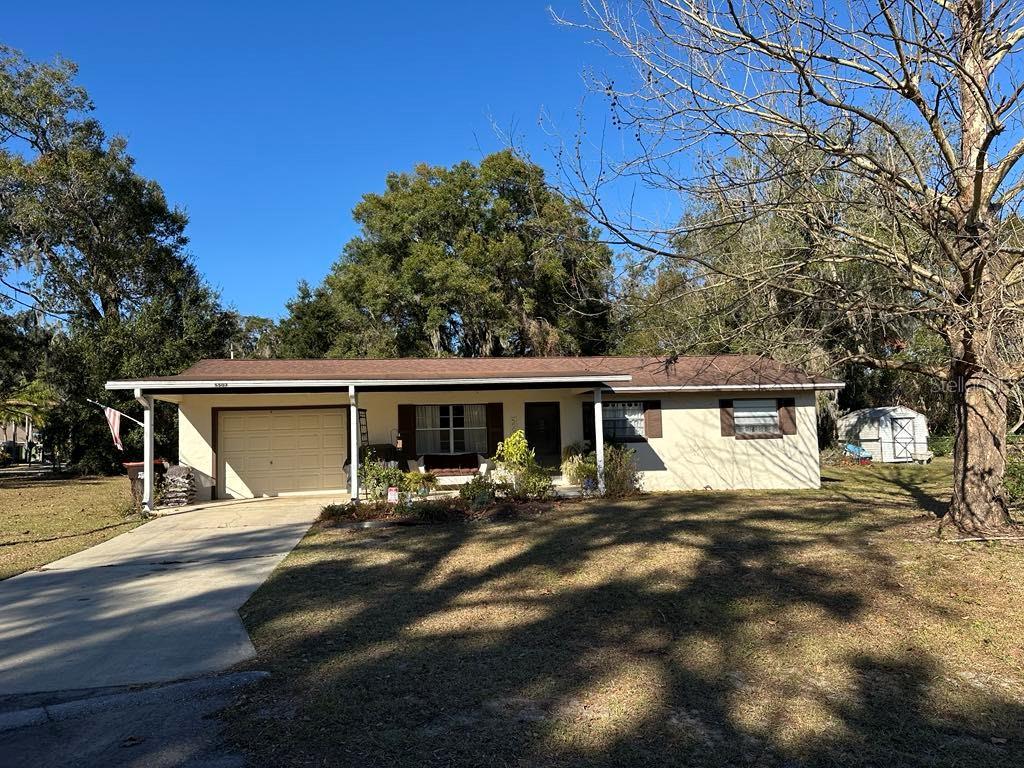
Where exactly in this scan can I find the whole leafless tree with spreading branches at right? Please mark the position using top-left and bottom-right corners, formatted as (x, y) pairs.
(570, 0), (1024, 530)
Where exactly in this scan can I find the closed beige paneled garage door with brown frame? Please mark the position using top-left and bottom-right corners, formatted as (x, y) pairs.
(217, 409), (346, 499)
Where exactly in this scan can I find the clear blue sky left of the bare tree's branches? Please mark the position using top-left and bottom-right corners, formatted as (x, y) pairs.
(2, 0), (608, 316)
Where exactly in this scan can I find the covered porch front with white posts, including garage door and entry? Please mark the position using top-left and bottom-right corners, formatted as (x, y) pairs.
(113, 382), (622, 508)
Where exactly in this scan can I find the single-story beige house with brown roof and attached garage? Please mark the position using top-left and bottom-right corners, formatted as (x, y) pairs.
(106, 355), (843, 514)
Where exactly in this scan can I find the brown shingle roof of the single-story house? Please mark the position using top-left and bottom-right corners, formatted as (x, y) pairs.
(125, 355), (841, 389)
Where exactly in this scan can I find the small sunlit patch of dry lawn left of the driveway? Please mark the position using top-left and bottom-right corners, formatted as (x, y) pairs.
(0, 477), (141, 579)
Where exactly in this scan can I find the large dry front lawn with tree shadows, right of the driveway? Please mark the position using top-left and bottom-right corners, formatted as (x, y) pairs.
(225, 462), (1024, 767)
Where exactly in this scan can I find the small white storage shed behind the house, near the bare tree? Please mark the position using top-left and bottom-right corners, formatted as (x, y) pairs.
(837, 406), (928, 463)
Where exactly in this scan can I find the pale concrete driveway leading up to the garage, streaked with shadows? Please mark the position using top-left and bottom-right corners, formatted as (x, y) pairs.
(0, 497), (329, 695)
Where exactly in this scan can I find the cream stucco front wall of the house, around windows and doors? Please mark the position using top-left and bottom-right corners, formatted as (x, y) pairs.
(177, 389), (820, 499)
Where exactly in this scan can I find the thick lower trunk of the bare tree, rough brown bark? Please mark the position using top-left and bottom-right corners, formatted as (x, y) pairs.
(948, 366), (1010, 534)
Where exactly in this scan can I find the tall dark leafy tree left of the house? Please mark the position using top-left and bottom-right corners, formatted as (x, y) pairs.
(0, 47), (238, 471)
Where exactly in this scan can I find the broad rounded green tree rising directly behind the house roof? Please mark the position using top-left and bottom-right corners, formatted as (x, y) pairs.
(280, 152), (611, 356)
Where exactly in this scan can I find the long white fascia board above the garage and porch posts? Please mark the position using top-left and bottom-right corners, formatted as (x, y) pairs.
(105, 374), (633, 391)
